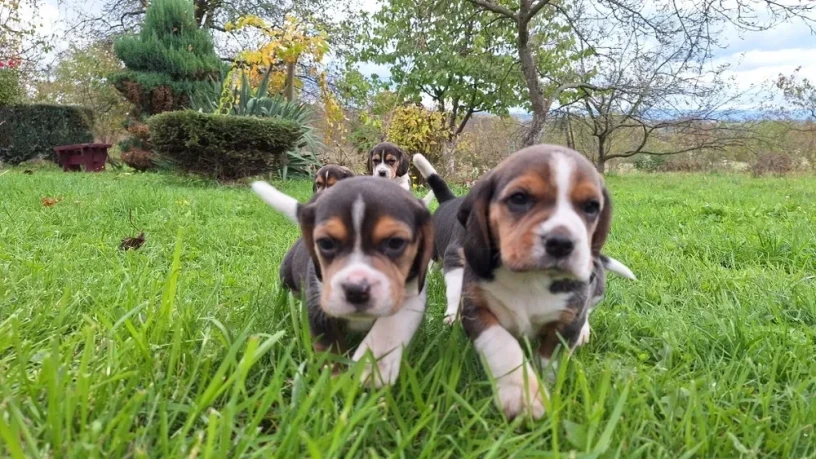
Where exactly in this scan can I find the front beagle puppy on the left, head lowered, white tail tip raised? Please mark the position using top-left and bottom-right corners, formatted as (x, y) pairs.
(252, 177), (433, 387)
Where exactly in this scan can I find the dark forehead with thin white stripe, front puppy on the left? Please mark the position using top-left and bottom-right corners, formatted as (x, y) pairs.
(315, 176), (419, 226)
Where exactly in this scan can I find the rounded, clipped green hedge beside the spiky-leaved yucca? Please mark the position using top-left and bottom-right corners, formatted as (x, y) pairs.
(148, 110), (302, 180)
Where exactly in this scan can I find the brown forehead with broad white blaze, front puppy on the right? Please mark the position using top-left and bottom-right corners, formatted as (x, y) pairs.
(495, 144), (600, 190)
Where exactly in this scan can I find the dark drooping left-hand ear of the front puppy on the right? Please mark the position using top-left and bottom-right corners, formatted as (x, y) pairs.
(456, 174), (499, 279)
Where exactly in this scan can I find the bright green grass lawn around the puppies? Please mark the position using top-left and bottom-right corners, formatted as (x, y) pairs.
(0, 169), (816, 458)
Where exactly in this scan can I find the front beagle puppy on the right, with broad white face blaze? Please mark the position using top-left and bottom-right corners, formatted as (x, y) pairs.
(414, 145), (634, 419)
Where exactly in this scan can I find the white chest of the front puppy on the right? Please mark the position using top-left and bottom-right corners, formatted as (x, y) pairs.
(481, 267), (570, 338)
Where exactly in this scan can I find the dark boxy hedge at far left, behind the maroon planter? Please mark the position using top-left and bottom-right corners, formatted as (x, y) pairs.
(0, 105), (93, 164)
